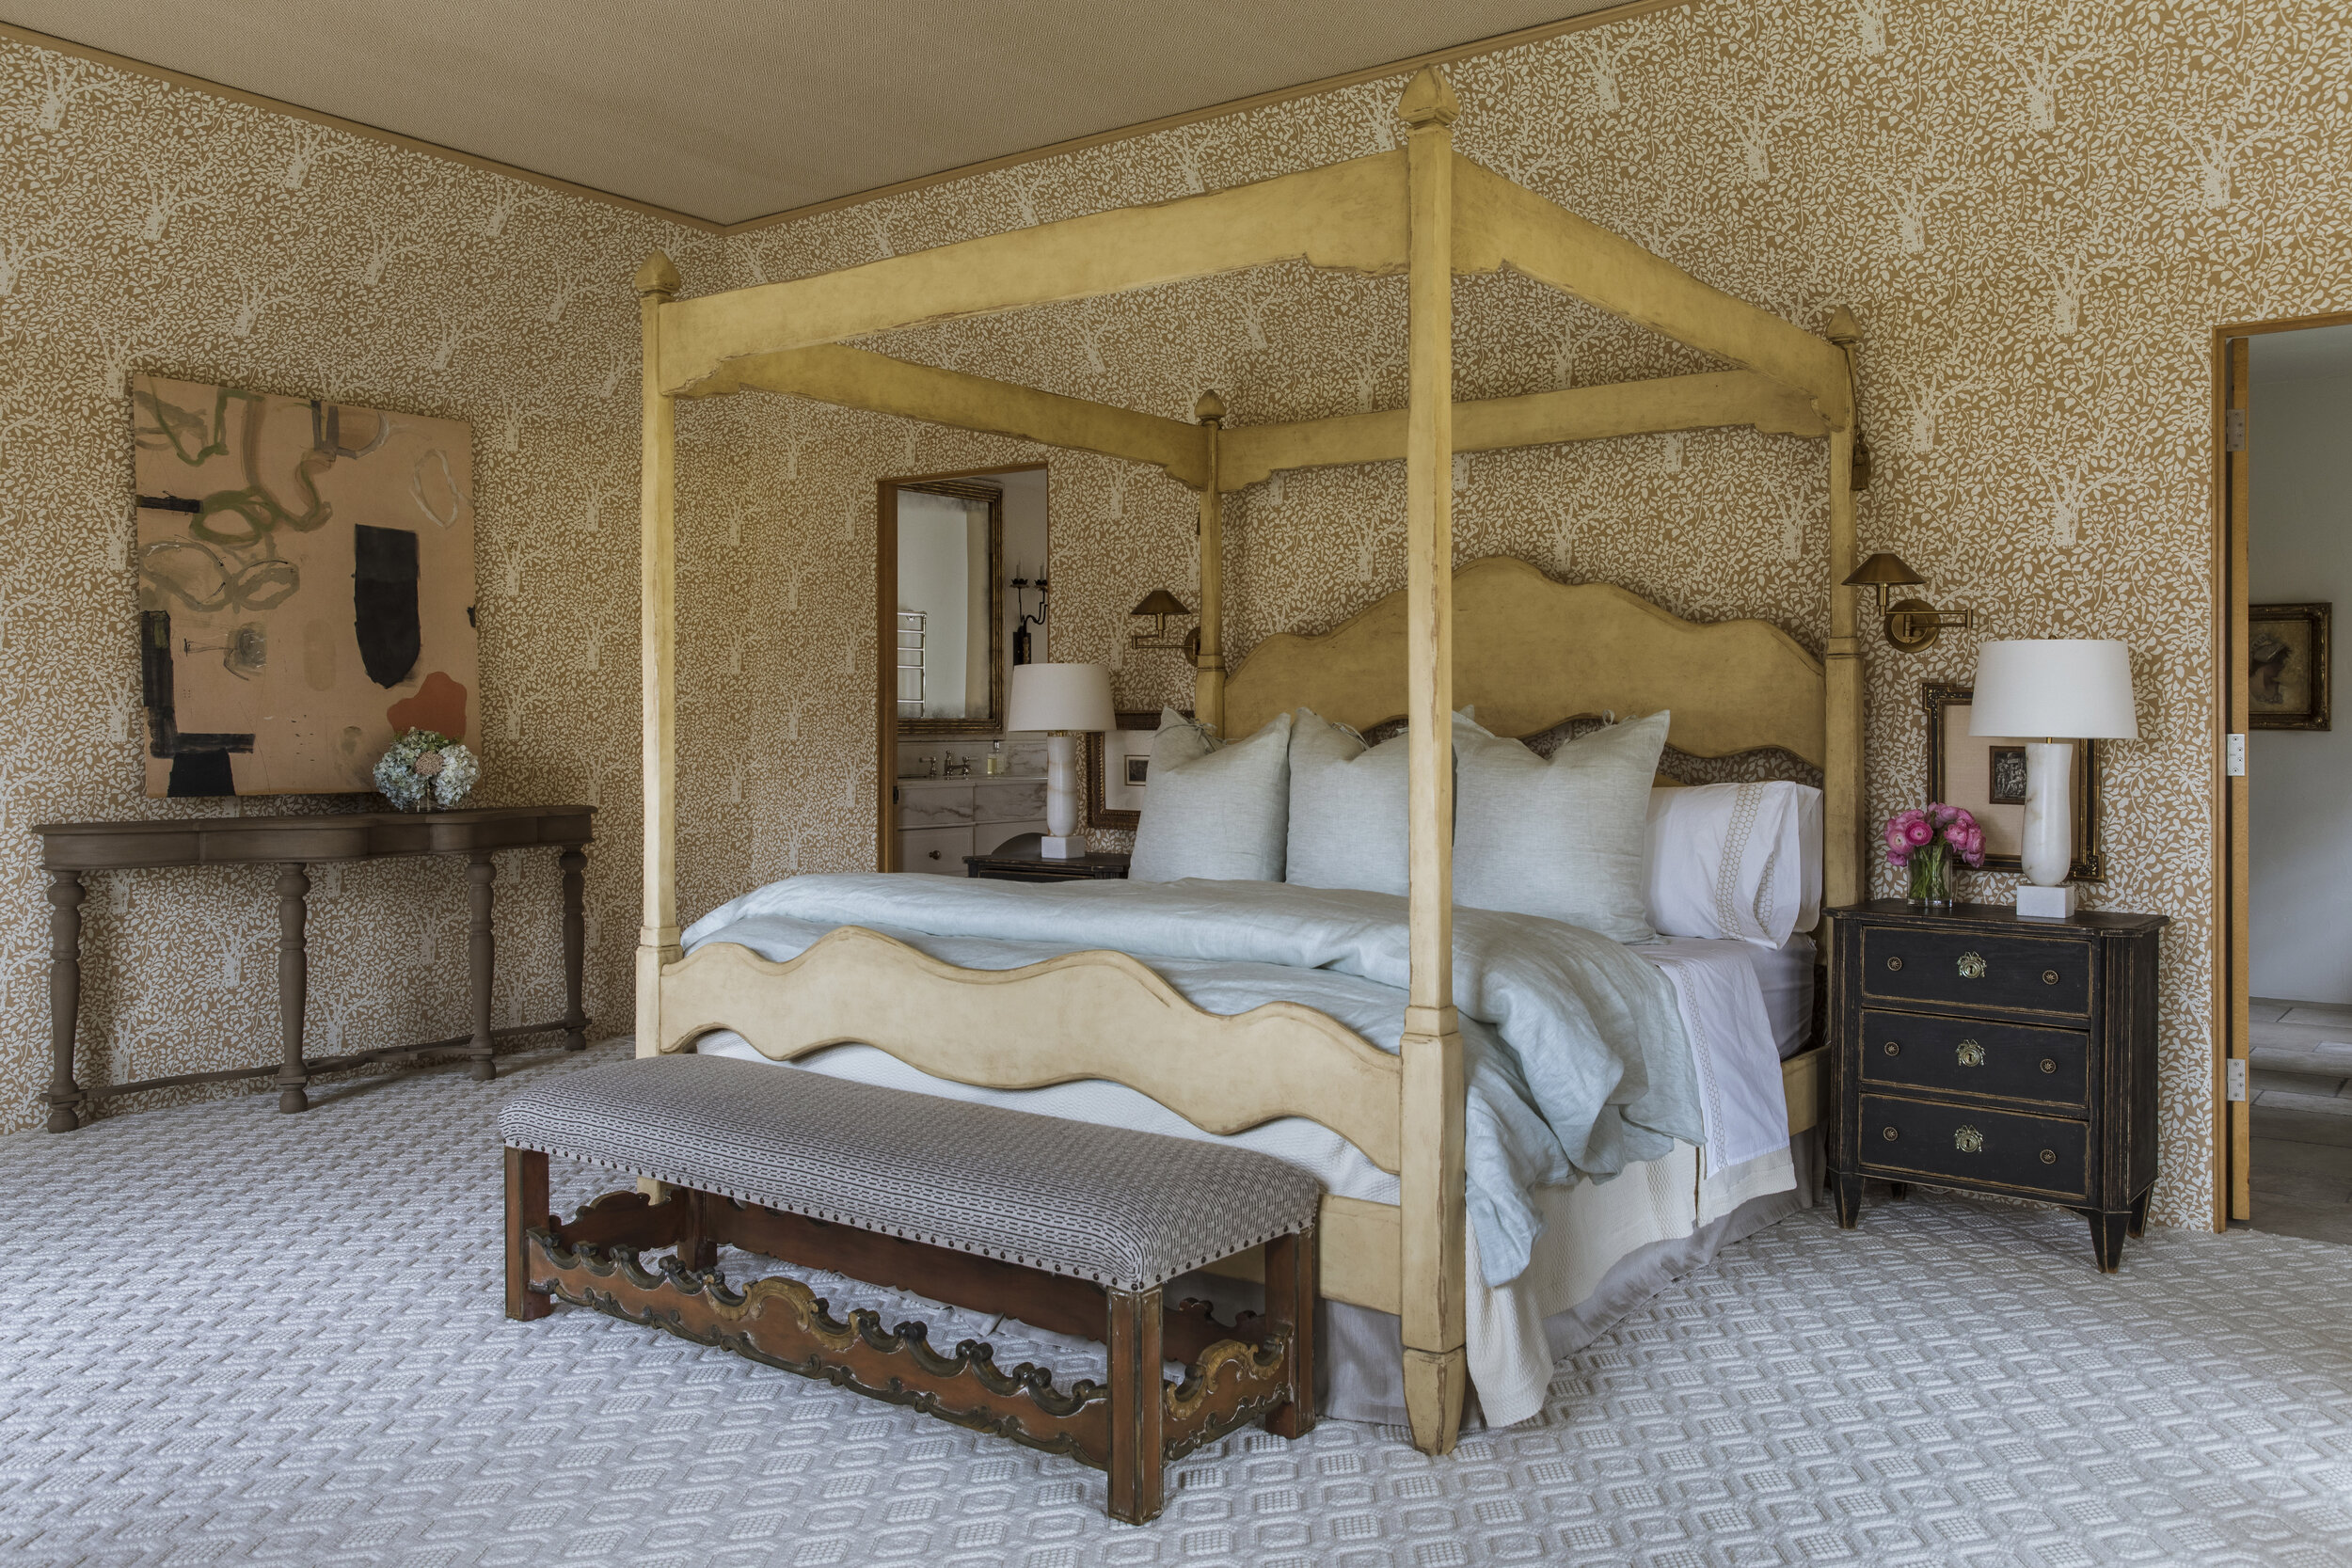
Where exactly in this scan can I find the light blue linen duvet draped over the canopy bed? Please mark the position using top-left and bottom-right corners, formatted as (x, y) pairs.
(685, 872), (1703, 1286)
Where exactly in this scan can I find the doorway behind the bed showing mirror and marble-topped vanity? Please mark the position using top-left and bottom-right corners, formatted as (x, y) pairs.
(875, 466), (1052, 877)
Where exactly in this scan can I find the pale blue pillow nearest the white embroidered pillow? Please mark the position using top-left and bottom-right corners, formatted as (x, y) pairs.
(1454, 712), (1670, 942)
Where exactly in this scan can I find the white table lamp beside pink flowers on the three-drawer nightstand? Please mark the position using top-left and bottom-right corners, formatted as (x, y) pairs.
(1969, 637), (2140, 919)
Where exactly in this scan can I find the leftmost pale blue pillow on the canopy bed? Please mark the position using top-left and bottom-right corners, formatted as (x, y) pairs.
(1127, 707), (1292, 881)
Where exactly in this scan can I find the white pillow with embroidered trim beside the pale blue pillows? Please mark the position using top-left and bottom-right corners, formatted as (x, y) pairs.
(1646, 781), (1820, 947)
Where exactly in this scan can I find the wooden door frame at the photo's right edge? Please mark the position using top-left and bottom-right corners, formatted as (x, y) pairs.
(2209, 310), (2352, 1229)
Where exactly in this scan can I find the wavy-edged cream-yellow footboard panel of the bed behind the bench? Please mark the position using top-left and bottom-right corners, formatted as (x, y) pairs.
(659, 927), (1402, 1171)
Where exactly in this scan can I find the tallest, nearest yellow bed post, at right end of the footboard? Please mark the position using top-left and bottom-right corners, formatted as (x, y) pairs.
(1397, 68), (1470, 1453)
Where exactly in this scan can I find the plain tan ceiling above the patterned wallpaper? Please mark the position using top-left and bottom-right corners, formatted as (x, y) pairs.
(0, 0), (1656, 223)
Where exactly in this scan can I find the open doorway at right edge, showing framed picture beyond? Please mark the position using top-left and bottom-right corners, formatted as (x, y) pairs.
(2214, 315), (2352, 1242)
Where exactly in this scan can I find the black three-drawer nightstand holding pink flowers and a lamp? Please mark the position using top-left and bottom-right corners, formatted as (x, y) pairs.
(1830, 898), (2169, 1275)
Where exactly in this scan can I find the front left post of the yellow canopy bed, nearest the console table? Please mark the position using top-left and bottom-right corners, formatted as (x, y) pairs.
(638, 251), (677, 1055)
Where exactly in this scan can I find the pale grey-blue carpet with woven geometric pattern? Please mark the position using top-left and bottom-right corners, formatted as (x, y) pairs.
(0, 1049), (2352, 1568)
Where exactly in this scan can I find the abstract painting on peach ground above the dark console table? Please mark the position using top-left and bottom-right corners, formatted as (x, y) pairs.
(132, 376), (480, 795)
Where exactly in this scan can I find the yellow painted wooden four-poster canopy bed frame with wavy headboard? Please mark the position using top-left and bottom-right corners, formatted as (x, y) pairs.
(638, 71), (1863, 1453)
